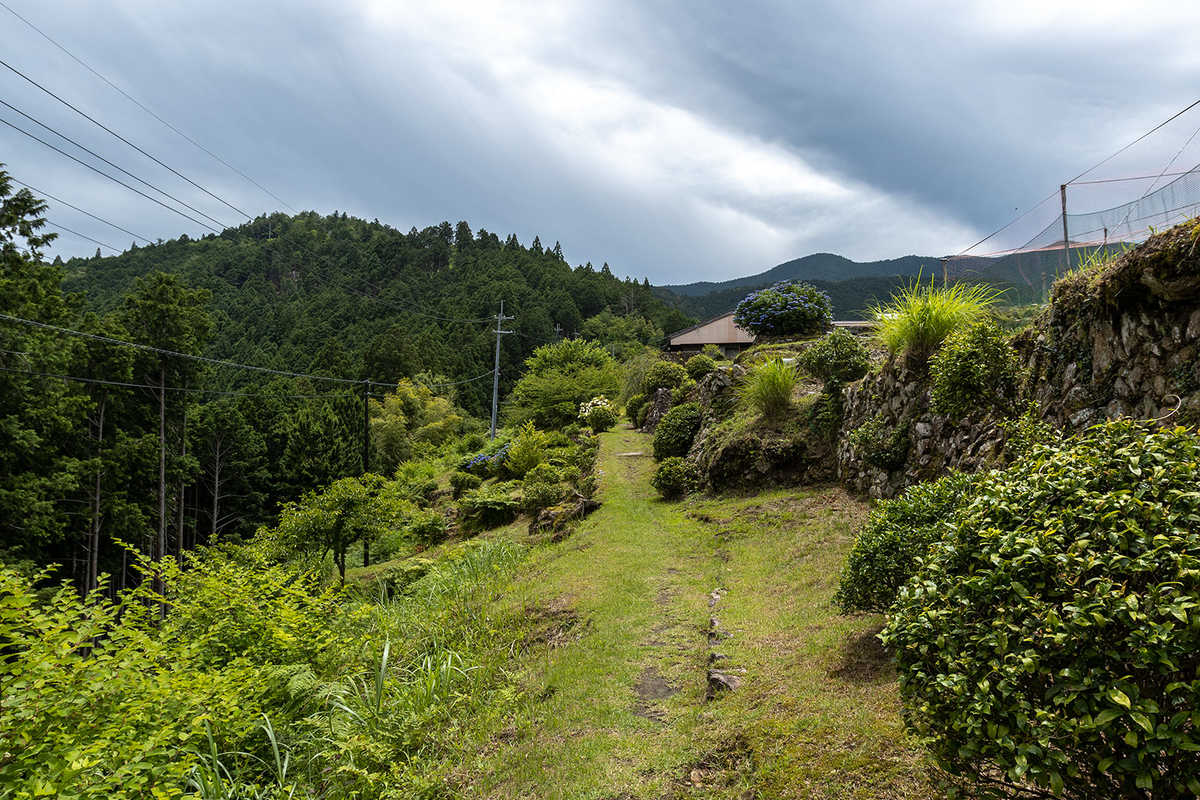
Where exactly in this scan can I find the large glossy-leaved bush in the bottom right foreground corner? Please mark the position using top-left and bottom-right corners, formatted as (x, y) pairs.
(883, 421), (1200, 798)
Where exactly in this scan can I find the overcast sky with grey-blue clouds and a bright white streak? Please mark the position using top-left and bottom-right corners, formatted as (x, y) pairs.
(0, 0), (1200, 284)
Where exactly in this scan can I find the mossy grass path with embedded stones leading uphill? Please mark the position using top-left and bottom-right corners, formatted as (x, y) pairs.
(461, 429), (935, 800)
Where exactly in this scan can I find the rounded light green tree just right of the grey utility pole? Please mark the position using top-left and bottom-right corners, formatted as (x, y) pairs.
(505, 339), (620, 431)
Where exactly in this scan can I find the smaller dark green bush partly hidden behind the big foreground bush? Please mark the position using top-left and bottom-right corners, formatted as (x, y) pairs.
(833, 473), (976, 614)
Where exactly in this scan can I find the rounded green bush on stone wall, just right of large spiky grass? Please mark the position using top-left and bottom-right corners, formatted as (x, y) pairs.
(929, 319), (1021, 419)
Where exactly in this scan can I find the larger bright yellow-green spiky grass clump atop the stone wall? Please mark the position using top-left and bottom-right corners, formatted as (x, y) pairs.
(871, 278), (1000, 362)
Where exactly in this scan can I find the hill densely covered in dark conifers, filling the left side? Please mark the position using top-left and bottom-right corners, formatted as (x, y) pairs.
(0, 170), (694, 591)
